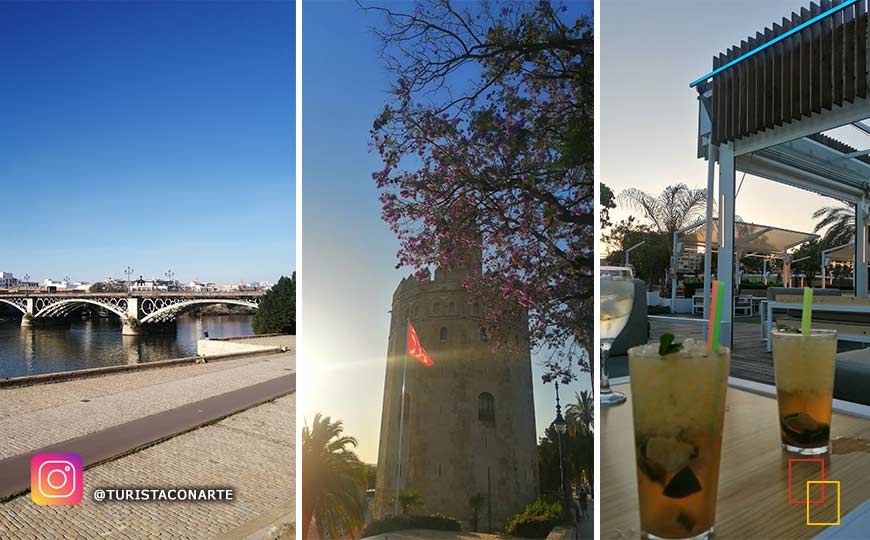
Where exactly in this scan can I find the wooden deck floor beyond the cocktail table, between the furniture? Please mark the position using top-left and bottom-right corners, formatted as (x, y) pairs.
(608, 319), (861, 384)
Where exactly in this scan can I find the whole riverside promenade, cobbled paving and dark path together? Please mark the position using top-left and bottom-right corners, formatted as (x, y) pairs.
(0, 336), (296, 539)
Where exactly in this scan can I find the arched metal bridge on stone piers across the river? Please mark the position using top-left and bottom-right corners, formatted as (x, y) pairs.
(0, 291), (263, 336)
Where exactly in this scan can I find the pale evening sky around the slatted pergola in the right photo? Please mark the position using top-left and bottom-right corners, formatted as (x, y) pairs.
(599, 0), (863, 248)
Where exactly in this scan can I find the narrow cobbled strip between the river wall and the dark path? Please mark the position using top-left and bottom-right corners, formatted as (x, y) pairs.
(0, 338), (296, 460)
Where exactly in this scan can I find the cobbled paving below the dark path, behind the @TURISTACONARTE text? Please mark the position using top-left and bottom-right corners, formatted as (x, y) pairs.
(0, 394), (296, 540)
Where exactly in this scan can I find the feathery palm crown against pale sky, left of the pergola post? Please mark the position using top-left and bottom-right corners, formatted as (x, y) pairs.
(619, 183), (707, 238)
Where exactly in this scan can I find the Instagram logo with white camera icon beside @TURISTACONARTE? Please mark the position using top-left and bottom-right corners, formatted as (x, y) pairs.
(30, 454), (84, 504)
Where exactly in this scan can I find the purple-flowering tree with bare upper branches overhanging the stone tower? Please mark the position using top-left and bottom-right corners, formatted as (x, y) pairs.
(363, 0), (594, 381)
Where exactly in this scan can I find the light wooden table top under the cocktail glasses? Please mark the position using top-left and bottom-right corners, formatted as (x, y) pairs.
(600, 384), (870, 540)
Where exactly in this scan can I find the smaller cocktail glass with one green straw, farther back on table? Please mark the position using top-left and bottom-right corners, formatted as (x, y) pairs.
(771, 330), (837, 455)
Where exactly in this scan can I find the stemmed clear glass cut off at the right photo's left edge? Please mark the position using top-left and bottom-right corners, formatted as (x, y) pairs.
(599, 266), (634, 405)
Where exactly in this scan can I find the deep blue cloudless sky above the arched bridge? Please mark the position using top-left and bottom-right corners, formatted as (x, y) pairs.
(0, 2), (295, 281)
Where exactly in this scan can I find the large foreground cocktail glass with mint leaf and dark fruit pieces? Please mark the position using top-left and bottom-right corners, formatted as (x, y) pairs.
(628, 340), (731, 539)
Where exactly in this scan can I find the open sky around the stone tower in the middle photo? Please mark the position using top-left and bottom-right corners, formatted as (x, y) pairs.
(300, 2), (591, 463)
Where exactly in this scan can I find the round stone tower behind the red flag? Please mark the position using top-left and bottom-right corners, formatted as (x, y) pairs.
(374, 256), (539, 531)
